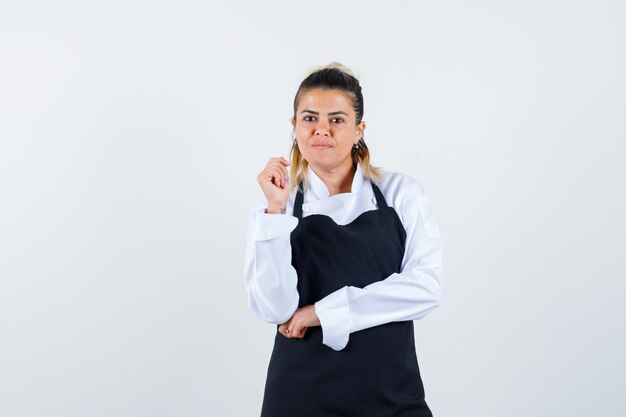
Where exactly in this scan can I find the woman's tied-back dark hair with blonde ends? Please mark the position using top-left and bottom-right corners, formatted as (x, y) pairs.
(289, 61), (384, 190)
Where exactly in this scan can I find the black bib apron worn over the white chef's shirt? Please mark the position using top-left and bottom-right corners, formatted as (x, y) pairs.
(261, 179), (432, 417)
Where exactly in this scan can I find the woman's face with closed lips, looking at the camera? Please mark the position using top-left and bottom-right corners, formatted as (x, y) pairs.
(291, 89), (365, 170)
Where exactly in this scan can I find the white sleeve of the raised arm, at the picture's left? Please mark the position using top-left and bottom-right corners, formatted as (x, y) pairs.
(244, 197), (299, 324)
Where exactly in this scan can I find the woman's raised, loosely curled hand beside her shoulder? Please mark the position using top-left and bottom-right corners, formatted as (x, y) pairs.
(257, 156), (291, 213)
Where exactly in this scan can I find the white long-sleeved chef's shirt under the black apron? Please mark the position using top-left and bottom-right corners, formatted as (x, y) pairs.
(244, 164), (443, 350)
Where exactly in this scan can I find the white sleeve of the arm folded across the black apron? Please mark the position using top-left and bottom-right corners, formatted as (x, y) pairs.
(315, 181), (443, 351)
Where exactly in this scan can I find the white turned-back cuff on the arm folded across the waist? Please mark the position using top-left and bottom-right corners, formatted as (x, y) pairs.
(315, 286), (350, 351)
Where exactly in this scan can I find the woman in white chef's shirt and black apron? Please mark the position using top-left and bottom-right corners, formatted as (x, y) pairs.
(245, 63), (443, 417)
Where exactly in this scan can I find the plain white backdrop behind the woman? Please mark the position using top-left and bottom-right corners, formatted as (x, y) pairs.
(0, 0), (626, 417)
